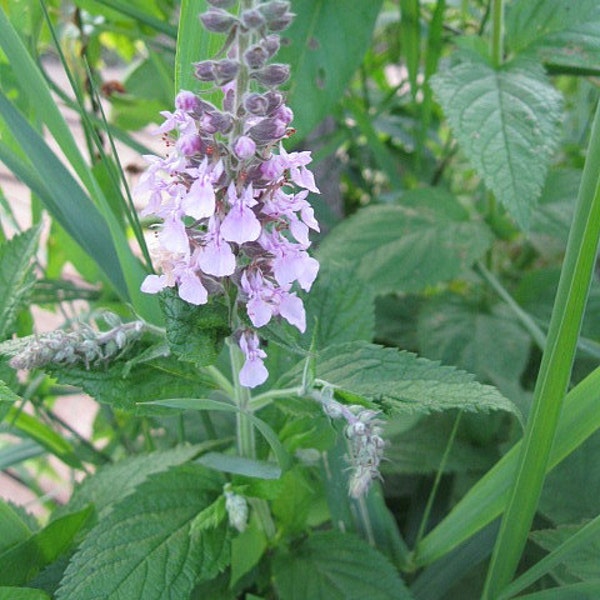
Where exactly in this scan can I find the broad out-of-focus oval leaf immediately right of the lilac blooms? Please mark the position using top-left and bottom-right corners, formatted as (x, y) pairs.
(318, 189), (492, 294)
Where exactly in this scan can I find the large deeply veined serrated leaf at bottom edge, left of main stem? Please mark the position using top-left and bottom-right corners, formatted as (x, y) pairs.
(57, 465), (224, 600)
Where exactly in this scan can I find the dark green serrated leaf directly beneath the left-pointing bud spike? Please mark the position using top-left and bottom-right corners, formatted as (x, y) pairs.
(49, 356), (214, 415)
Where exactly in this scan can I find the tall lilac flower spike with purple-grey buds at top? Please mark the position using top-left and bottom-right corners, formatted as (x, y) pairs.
(137, 0), (319, 387)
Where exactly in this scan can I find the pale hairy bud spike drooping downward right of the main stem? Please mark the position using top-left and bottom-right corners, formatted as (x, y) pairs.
(315, 387), (385, 498)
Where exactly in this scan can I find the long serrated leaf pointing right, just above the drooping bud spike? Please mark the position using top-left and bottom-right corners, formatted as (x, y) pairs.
(284, 342), (518, 414)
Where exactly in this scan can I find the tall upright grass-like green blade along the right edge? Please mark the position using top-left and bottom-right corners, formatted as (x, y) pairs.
(483, 98), (600, 600)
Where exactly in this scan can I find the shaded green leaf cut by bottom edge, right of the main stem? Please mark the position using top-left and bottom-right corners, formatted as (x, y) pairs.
(273, 531), (412, 600)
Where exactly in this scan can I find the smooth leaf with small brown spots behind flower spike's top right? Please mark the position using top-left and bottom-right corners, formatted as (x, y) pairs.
(277, 0), (382, 137)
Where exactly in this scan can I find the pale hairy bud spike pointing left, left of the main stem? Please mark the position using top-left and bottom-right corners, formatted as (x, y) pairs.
(3, 314), (144, 369)
